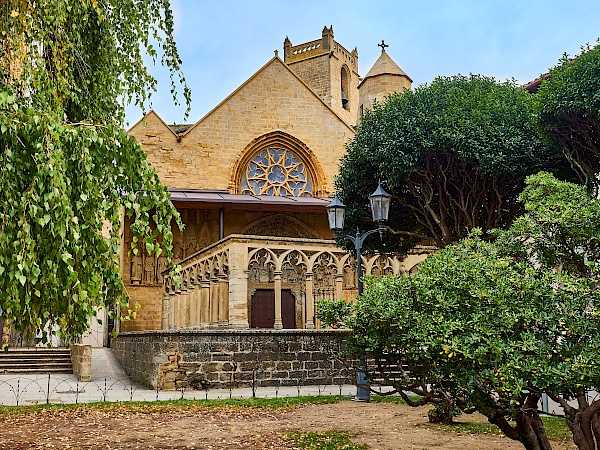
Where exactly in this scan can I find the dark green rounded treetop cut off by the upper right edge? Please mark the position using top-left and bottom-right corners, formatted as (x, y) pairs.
(535, 44), (600, 193)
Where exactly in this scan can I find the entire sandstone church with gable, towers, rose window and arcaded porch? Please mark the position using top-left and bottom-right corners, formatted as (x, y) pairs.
(121, 27), (425, 331)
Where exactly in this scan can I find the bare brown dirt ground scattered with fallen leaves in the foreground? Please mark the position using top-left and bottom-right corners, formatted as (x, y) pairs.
(0, 401), (575, 450)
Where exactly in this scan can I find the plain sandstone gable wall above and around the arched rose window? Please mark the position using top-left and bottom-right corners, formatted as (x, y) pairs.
(130, 58), (354, 196)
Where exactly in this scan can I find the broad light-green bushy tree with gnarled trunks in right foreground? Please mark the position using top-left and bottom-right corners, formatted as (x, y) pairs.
(322, 173), (600, 450)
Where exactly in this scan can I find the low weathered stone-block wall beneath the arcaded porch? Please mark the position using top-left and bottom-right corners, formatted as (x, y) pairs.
(111, 330), (354, 390)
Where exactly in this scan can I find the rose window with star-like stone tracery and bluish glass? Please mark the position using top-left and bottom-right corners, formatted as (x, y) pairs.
(242, 148), (312, 197)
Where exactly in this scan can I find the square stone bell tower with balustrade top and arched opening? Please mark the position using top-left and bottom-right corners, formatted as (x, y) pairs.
(283, 26), (359, 125)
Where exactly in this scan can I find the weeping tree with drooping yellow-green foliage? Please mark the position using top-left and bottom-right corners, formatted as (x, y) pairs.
(0, 0), (189, 340)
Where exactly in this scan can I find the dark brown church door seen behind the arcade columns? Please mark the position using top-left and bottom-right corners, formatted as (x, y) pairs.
(250, 289), (296, 328)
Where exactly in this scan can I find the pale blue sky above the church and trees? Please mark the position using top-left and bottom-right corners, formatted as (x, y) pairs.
(127, 0), (600, 124)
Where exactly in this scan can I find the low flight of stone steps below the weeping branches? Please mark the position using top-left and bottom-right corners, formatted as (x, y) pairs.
(0, 347), (73, 375)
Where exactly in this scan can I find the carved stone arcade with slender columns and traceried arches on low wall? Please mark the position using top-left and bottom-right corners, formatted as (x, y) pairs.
(162, 235), (426, 330)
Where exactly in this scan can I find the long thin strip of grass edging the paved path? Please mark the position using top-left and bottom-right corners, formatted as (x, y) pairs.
(0, 395), (348, 420)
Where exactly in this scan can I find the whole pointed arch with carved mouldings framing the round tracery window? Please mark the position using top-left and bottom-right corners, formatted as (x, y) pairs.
(229, 131), (326, 197)
